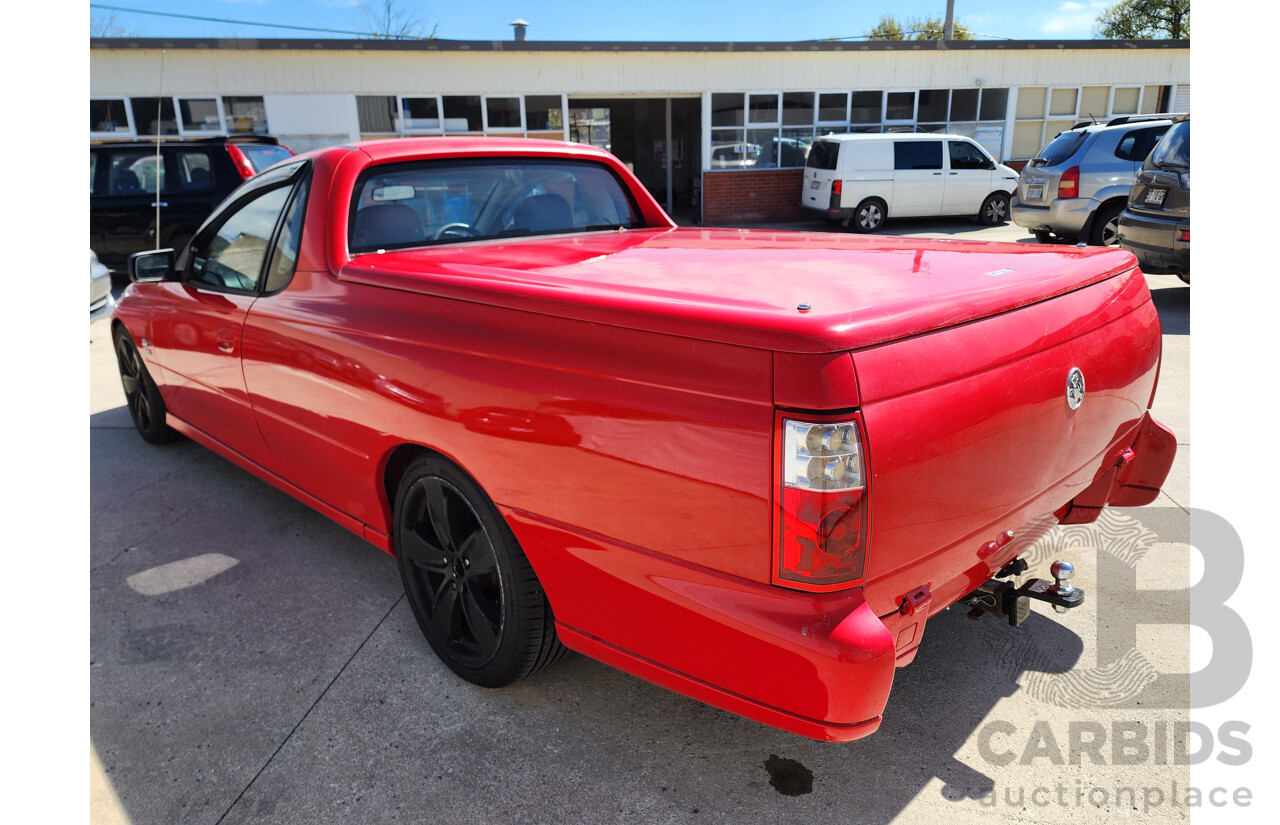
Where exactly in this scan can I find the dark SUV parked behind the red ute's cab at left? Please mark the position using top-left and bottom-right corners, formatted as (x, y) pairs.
(88, 136), (293, 270)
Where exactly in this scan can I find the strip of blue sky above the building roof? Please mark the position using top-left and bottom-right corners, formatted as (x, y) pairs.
(90, 0), (1141, 41)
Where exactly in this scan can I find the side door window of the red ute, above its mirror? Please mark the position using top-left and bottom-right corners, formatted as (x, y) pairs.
(186, 185), (292, 292)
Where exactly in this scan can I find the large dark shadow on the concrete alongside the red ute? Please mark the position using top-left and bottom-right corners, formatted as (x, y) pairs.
(97, 408), (1152, 825)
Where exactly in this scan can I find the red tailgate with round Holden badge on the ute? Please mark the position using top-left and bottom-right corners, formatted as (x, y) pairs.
(854, 269), (1161, 615)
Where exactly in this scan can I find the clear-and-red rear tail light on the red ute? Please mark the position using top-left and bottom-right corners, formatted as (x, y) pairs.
(773, 417), (868, 591)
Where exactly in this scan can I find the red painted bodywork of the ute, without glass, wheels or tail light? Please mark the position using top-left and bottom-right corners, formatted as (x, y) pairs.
(116, 139), (1174, 739)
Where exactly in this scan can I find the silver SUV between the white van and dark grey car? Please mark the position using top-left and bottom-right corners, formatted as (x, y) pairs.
(1010, 114), (1175, 247)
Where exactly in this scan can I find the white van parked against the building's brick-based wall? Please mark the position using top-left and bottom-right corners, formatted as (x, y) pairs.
(800, 133), (1018, 232)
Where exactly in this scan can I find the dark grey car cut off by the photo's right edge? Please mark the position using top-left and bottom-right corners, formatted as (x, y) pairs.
(1116, 115), (1192, 284)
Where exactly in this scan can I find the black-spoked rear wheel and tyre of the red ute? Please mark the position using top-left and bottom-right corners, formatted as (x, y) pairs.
(394, 454), (566, 687)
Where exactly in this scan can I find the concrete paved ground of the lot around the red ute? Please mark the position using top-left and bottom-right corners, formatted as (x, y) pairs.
(90, 221), (1198, 825)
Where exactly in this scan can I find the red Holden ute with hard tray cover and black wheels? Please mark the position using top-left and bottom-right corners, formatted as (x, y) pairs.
(113, 138), (1175, 741)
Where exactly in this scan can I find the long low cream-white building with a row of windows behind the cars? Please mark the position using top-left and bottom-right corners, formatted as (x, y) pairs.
(90, 38), (1190, 223)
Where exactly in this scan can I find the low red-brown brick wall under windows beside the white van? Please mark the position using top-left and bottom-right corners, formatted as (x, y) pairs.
(703, 169), (812, 226)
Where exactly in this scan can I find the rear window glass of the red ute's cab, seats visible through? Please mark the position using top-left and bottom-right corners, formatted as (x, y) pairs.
(349, 157), (641, 253)
